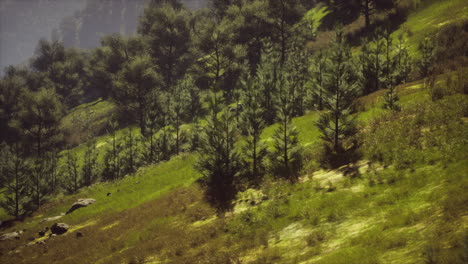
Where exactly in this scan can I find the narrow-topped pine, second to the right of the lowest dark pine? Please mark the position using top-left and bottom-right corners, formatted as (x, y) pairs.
(270, 75), (302, 182)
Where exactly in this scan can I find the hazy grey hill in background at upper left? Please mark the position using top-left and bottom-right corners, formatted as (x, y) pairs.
(0, 0), (207, 75)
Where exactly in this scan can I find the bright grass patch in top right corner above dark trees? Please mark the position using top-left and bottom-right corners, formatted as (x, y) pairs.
(392, 0), (468, 56)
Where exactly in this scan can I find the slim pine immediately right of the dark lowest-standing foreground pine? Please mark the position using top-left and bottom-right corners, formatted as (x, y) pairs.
(241, 77), (267, 185)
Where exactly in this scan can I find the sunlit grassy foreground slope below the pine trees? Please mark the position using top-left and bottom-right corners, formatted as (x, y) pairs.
(0, 73), (468, 263)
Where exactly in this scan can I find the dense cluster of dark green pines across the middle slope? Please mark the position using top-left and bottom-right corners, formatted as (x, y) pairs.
(0, 0), (432, 217)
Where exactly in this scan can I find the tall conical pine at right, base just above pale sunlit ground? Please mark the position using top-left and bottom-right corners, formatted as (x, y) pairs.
(316, 30), (357, 166)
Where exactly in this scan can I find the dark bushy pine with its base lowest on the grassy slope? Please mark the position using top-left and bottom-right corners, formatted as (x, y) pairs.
(196, 94), (240, 212)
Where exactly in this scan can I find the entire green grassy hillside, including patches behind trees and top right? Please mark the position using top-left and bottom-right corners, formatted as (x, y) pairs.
(0, 0), (468, 264)
